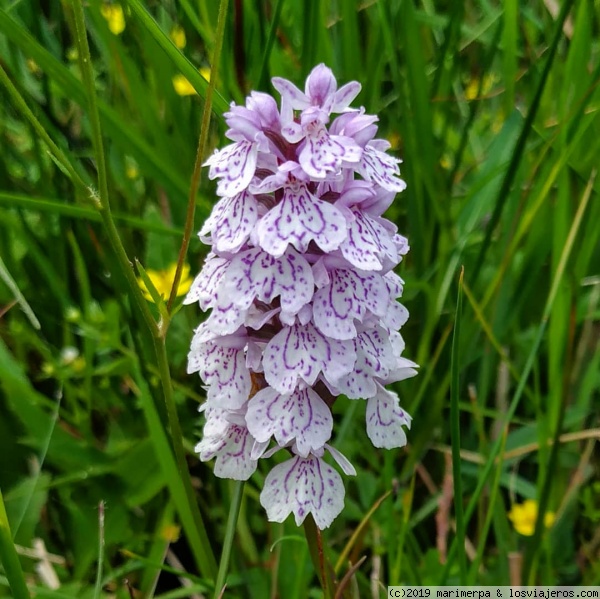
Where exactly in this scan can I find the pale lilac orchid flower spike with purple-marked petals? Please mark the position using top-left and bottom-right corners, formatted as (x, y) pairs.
(185, 64), (417, 528)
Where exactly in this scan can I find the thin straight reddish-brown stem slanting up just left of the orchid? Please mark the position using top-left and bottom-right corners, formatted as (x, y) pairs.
(168, 0), (229, 314)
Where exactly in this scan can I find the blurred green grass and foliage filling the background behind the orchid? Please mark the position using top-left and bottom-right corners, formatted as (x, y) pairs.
(0, 0), (600, 599)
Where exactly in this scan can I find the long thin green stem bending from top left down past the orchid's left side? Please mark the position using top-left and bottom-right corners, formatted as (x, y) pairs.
(70, 0), (216, 578)
